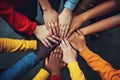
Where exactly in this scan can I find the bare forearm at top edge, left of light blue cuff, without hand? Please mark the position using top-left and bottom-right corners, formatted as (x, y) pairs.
(39, 0), (52, 12)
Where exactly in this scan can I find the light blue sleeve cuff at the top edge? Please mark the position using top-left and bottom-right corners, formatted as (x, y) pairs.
(64, 0), (79, 10)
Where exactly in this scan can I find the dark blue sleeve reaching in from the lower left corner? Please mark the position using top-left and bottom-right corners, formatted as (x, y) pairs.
(0, 52), (38, 80)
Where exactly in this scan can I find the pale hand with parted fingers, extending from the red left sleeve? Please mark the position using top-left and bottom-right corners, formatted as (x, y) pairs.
(34, 25), (60, 47)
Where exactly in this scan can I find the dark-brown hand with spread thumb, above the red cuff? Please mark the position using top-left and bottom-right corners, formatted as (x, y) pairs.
(45, 48), (65, 76)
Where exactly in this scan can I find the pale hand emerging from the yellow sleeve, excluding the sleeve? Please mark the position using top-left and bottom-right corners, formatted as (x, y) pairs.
(60, 40), (77, 64)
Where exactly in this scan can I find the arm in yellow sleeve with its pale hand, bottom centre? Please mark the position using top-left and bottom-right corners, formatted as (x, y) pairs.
(60, 40), (86, 80)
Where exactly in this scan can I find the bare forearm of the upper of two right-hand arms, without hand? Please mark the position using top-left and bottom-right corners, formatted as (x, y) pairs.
(77, 0), (116, 22)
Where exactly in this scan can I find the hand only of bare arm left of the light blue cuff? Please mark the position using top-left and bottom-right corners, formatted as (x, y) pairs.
(43, 8), (59, 35)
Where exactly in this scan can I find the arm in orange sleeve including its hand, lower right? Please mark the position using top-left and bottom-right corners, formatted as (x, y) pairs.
(69, 31), (120, 80)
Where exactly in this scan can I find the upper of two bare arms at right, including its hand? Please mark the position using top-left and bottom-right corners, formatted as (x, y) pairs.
(68, 0), (116, 36)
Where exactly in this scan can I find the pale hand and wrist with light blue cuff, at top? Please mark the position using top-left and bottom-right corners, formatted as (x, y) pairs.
(59, 0), (79, 38)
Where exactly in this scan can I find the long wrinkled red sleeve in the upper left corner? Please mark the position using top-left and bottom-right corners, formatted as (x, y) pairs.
(0, 0), (36, 35)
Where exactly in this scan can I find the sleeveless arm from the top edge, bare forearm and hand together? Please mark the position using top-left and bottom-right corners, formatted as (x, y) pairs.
(39, 0), (59, 35)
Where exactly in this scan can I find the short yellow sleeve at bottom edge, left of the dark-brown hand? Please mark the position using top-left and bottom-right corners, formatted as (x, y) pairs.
(33, 69), (50, 80)
